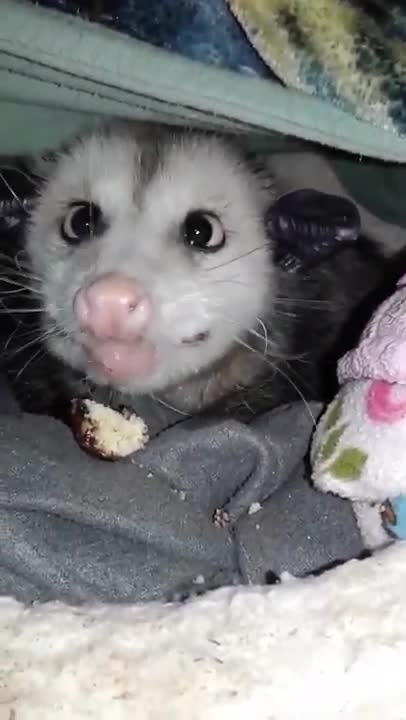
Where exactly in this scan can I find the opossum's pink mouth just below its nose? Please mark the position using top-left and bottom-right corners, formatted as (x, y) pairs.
(85, 340), (156, 383)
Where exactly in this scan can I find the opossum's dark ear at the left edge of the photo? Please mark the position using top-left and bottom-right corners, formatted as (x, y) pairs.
(0, 162), (38, 235)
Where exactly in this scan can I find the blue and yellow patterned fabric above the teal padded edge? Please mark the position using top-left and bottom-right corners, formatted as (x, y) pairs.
(32, 0), (406, 135)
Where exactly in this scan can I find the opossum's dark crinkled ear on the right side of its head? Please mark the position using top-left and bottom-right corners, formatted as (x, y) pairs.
(265, 189), (361, 272)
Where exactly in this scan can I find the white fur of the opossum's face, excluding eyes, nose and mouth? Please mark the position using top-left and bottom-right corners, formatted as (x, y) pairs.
(27, 124), (273, 394)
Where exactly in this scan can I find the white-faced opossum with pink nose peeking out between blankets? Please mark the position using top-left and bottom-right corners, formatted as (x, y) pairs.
(0, 121), (385, 415)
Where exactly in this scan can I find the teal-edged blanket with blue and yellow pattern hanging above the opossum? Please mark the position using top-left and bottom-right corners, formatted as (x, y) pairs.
(0, 0), (406, 227)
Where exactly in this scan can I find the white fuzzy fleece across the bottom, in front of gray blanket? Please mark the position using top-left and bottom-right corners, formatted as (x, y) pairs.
(0, 543), (406, 720)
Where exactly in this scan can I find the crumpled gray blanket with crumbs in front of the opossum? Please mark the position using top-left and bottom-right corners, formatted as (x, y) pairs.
(0, 384), (363, 603)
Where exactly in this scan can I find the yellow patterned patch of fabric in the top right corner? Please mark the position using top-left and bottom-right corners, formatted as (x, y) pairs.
(228, 0), (406, 136)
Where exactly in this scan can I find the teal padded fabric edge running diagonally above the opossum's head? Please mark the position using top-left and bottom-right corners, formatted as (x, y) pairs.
(0, 0), (406, 162)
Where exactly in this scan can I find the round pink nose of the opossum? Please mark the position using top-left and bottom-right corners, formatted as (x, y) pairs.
(73, 273), (152, 340)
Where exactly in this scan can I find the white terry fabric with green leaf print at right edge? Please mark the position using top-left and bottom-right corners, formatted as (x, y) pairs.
(313, 380), (406, 548)
